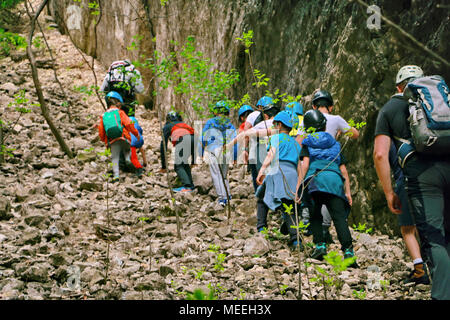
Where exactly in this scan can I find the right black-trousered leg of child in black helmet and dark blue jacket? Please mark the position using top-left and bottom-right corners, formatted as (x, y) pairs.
(325, 195), (353, 251)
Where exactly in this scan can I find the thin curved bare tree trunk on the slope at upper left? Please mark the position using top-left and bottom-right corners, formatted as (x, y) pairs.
(27, 0), (73, 159)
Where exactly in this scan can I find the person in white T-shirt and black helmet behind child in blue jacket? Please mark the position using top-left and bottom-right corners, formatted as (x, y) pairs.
(297, 90), (359, 243)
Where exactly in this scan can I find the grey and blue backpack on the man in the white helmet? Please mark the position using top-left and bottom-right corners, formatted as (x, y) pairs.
(396, 75), (450, 160)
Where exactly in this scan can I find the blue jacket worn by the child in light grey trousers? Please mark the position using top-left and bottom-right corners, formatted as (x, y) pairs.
(199, 116), (237, 160)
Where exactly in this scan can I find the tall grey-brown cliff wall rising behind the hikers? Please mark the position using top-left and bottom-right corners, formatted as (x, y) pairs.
(50, 0), (450, 233)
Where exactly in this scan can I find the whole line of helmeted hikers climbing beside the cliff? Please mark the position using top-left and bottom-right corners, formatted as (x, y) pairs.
(98, 61), (450, 300)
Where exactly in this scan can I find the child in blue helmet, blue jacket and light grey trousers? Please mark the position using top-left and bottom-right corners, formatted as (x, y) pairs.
(199, 100), (237, 206)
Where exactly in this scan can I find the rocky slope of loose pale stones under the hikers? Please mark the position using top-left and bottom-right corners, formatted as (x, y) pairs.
(0, 9), (429, 299)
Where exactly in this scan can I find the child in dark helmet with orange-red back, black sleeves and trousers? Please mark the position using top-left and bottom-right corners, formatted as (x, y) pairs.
(160, 111), (195, 192)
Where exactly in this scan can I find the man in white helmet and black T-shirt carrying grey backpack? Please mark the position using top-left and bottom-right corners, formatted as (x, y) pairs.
(373, 65), (450, 300)
